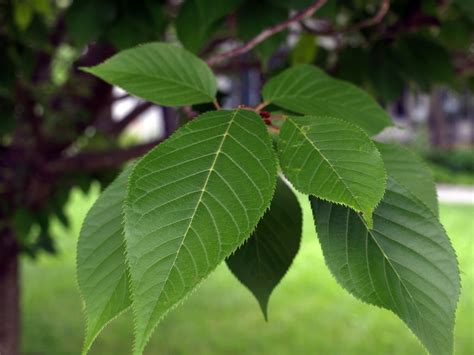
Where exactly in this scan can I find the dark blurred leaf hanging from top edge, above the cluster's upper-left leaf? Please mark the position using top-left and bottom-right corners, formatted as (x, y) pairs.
(176, 0), (242, 53)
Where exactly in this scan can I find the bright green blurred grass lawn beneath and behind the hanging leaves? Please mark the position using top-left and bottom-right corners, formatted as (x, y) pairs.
(22, 188), (474, 355)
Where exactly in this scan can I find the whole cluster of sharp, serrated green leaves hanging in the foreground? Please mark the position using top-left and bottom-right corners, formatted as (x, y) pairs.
(77, 43), (460, 354)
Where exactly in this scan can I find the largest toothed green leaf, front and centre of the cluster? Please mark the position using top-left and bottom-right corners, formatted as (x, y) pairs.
(125, 109), (276, 354)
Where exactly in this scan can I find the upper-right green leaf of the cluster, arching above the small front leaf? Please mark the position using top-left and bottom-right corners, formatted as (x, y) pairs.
(262, 64), (391, 135)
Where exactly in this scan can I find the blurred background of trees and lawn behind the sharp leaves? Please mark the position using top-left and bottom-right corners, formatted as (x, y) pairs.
(0, 0), (474, 355)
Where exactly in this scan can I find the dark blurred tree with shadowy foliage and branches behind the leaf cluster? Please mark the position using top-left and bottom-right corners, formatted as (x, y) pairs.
(0, 0), (474, 354)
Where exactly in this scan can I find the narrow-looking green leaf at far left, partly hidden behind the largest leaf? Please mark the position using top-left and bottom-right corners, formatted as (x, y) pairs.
(77, 165), (133, 354)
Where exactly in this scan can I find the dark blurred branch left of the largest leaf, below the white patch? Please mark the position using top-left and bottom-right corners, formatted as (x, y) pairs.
(46, 138), (163, 174)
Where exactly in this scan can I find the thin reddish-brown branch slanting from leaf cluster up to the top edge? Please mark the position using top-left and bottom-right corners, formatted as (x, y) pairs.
(207, 0), (326, 66)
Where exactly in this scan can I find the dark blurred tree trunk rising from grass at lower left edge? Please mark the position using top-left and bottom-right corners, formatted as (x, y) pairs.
(0, 228), (20, 355)
